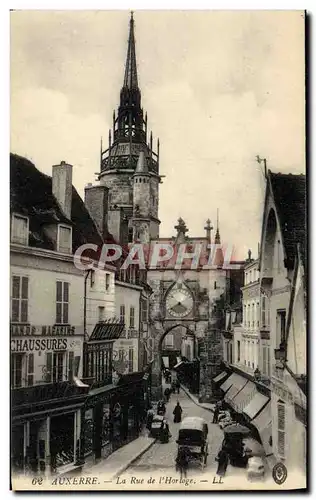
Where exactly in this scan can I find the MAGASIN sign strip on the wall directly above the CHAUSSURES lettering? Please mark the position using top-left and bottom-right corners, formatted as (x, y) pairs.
(10, 323), (79, 337)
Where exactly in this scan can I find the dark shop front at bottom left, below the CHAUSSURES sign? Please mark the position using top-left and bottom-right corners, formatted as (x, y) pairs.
(11, 382), (87, 475)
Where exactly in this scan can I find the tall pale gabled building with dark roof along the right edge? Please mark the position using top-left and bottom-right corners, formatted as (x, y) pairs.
(260, 171), (306, 475)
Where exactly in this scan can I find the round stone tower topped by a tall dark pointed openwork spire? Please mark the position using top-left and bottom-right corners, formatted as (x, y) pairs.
(98, 14), (161, 244)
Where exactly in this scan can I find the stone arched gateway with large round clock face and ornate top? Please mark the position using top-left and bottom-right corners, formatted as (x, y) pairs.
(147, 219), (227, 401)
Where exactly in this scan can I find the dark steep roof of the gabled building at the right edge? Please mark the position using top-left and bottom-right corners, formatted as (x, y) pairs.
(269, 170), (306, 268)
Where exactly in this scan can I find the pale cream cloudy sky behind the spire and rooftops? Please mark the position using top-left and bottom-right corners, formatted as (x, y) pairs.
(10, 10), (305, 258)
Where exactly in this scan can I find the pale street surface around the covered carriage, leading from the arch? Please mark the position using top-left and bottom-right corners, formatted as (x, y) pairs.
(125, 382), (245, 482)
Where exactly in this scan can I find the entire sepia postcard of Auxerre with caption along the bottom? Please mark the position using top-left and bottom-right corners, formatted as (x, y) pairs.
(10, 10), (308, 492)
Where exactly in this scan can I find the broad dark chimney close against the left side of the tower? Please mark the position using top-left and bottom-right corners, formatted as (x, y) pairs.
(84, 183), (109, 238)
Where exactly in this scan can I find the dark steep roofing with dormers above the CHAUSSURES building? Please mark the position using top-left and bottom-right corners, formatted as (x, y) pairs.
(10, 153), (115, 252)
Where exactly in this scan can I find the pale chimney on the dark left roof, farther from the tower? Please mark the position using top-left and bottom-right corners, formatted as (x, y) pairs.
(52, 161), (72, 220)
